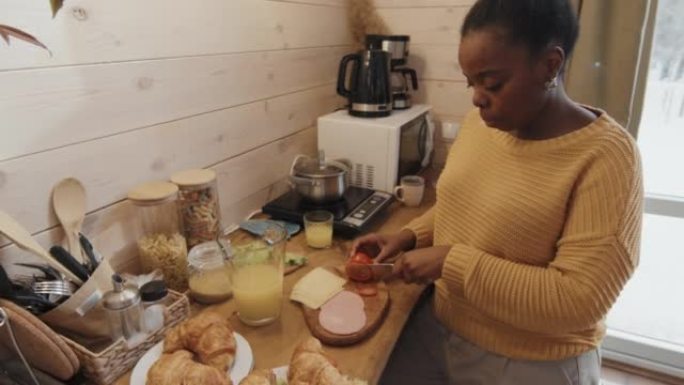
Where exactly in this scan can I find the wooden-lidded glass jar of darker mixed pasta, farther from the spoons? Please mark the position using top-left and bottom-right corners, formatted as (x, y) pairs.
(171, 169), (221, 249)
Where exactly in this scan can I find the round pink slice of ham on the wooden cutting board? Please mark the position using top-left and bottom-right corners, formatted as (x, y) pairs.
(318, 290), (366, 335)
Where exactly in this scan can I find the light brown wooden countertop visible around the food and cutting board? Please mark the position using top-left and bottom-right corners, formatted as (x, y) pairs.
(115, 183), (434, 385)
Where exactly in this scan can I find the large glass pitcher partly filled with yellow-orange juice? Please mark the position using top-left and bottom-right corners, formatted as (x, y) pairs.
(229, 223), (287, 326)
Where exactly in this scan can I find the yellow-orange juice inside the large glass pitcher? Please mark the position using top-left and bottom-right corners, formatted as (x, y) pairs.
(233, 265), (283, 325)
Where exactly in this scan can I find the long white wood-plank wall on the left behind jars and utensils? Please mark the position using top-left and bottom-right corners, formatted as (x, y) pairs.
(0, 0), (351, 271)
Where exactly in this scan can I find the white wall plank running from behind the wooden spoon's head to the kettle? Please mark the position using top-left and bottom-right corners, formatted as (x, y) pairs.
(0, 84), (341, 240)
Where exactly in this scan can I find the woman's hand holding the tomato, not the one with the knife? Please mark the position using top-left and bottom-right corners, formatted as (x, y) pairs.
(349, 230), (416, 262)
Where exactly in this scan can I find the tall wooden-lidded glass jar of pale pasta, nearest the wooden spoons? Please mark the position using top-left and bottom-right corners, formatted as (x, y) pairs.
(128, 182), (188, 292)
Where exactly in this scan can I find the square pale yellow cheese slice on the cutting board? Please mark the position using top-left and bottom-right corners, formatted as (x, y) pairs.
(290, 267), (347, 309)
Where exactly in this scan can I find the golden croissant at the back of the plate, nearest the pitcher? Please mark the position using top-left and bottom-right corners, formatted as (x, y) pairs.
(164, 312), (236, 373)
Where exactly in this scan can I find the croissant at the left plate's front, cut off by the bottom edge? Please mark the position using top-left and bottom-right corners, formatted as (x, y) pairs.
(146, 350), (232, 385)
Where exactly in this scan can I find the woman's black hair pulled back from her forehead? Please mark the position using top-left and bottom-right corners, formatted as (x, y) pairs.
(461, 0), (579, 57)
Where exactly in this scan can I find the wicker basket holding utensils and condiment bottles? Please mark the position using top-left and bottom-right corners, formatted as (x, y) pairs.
(62, 290), (190, 385)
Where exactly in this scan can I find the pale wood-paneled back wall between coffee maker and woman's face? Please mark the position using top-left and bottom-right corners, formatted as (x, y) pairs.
(375, 0), (475, 163)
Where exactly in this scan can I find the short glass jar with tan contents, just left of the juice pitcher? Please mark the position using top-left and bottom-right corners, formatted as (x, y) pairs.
(188, 241), (233, 304)
